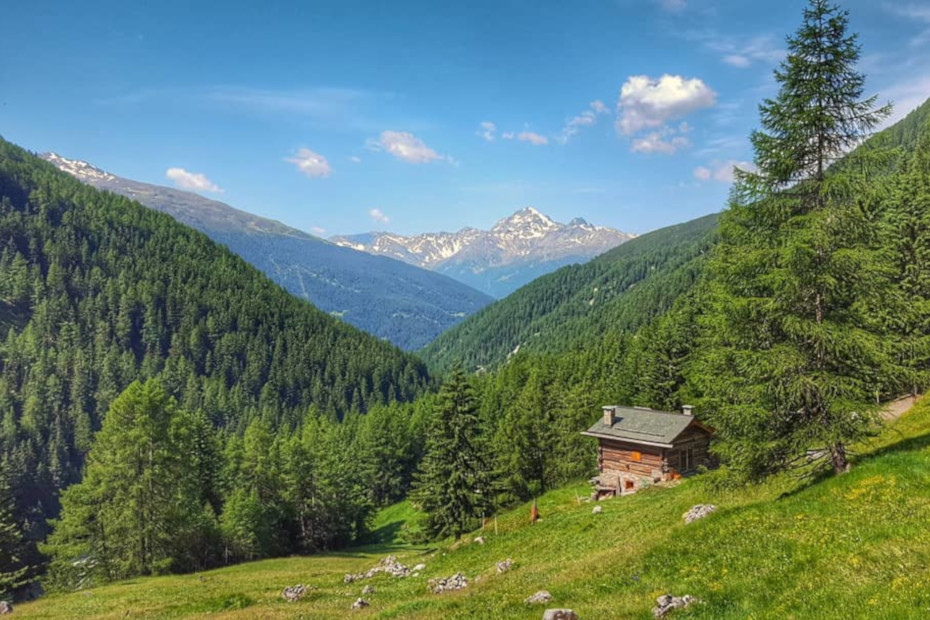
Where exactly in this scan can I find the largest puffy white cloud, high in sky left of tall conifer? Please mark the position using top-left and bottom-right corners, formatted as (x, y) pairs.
(616, 74), (717, 135)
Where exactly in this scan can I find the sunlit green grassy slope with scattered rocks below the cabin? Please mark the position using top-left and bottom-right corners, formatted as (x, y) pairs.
(17, 399), (930, 619)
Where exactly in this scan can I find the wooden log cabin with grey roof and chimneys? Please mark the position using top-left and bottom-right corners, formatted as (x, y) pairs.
(582, 405), (714, 499)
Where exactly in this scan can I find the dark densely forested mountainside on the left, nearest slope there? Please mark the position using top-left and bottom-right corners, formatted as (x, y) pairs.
(0, 141), (428, 572)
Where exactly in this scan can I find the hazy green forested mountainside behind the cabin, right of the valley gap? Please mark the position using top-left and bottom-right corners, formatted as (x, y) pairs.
(423, 215), (717, 370)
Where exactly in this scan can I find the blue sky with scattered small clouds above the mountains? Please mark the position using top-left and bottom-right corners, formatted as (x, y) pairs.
(0, 0), (930, 236)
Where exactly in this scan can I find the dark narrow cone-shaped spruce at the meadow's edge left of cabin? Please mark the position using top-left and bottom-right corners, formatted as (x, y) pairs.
(412, 366), (490, 538)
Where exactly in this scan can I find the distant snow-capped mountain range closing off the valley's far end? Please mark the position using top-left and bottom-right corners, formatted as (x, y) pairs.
(332, 207), (634, 298)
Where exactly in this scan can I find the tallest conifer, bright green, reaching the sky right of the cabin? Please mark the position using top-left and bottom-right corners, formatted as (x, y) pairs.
(696, 0), (889, 477)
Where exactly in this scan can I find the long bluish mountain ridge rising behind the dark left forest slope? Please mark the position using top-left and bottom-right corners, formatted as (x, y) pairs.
(41, 153), (492, 350)
